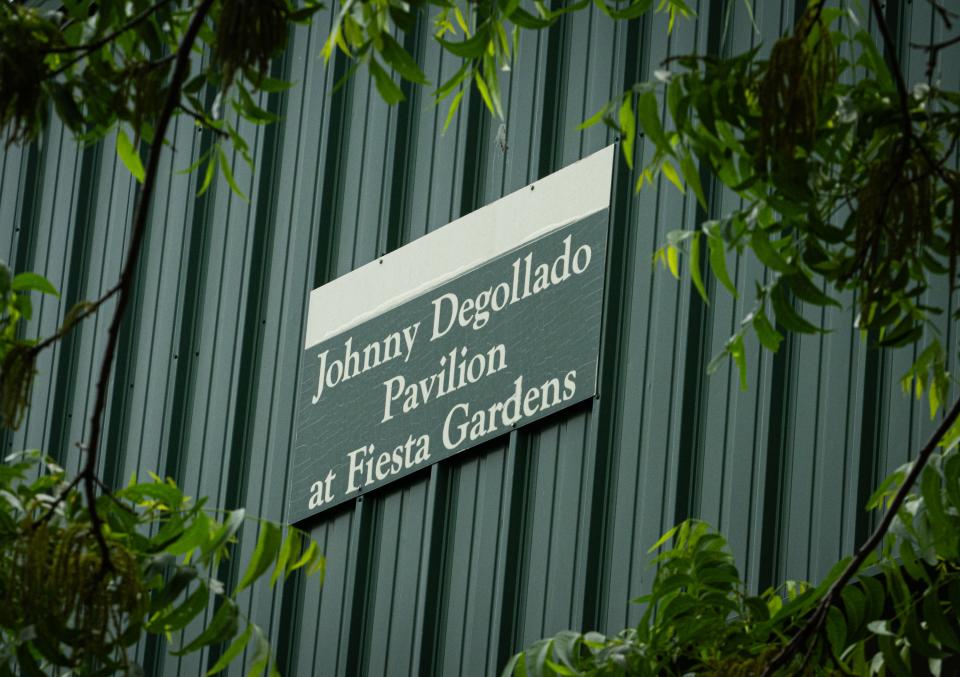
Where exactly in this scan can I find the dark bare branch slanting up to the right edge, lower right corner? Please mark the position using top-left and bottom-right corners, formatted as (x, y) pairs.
(763, 400), (960, 677)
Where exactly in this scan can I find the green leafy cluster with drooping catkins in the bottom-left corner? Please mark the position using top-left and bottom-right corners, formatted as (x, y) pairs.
(0, 451), (324, 674)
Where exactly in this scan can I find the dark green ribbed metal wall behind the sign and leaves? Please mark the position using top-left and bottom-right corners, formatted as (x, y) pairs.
(0, 0), (960, 675)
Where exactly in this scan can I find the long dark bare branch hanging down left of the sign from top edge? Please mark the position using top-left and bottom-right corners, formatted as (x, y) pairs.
(80, 0), (213, 572)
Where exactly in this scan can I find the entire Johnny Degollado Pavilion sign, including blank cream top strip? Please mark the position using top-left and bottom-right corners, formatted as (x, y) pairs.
(289, 147), (613, 522)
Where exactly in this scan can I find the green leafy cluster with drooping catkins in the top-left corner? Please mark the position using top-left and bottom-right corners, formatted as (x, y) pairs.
(0, 0), (321, 193)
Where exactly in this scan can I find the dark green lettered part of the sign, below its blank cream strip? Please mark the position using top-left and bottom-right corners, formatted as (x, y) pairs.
(290, 209), (608, 522)
